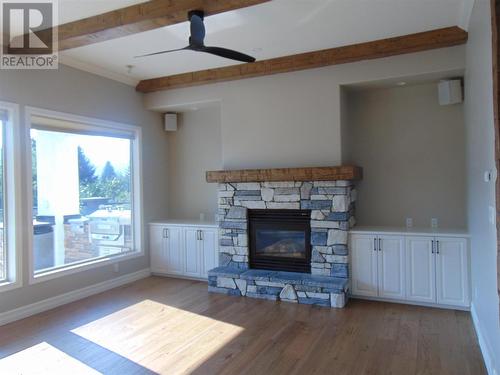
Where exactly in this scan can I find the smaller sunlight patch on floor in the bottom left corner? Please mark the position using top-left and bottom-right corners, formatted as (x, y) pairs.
(0, 342), (100, 375)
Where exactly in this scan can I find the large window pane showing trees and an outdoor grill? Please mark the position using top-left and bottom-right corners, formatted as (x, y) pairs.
(30, 108), (141, 278)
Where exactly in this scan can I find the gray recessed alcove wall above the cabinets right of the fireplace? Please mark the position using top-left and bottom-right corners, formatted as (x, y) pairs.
(342, 83), (466, 228)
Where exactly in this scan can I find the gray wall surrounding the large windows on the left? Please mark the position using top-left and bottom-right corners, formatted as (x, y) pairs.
(0, 66), (168, 312)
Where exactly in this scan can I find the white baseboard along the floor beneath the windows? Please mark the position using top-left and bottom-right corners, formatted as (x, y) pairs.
(0, 268), (151, 326)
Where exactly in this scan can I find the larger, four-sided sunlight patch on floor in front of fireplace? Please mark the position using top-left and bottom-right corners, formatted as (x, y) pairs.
(71, 299), (244, 371)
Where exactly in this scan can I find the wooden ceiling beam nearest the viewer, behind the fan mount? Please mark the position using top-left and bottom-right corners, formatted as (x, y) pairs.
(27, 0), (270, 51)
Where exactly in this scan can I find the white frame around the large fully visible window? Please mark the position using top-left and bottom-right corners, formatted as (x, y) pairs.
(24, 107), (145, 285)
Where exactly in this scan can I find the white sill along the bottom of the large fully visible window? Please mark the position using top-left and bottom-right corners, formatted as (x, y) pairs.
(29, 251), (144, 285)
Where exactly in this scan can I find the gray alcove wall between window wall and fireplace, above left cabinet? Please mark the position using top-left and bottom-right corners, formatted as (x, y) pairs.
(168, 107), (222, 220)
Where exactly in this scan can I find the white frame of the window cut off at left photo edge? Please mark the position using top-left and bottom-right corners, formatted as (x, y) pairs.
(0, 101), (23, 292)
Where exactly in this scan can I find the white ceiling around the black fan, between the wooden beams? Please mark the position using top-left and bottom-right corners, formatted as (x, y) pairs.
(59, 0), (471, 84)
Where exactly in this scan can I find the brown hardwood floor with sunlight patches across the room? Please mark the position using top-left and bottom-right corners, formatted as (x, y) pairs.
(0, 277), (486, 375)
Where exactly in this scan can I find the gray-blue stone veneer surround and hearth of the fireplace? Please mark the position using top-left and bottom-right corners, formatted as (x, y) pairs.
(209, 180), (356, 307)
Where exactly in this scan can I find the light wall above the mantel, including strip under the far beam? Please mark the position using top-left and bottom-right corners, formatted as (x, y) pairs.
(145, 46), (464, 169)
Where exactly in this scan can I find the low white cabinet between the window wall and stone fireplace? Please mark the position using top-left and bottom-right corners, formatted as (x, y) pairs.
(150, 223), (218, 279)
